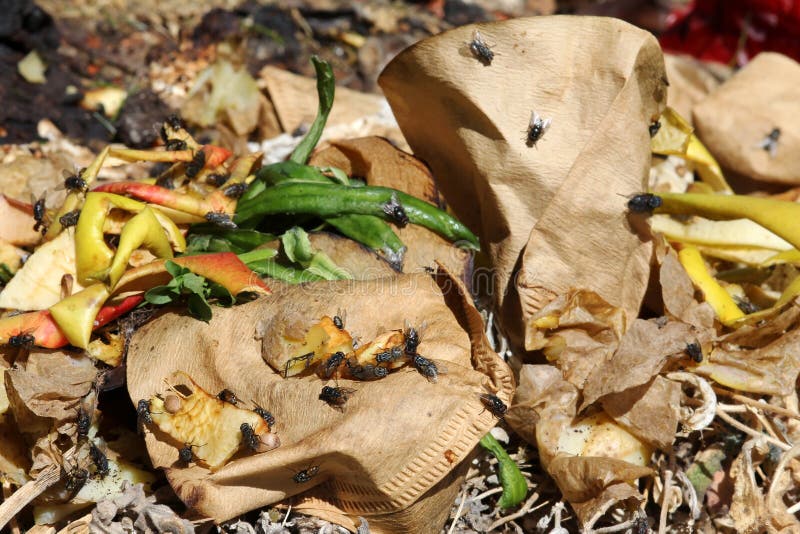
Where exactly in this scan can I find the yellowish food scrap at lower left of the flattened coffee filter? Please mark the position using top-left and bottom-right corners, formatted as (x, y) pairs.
(150, 373), (270, 470)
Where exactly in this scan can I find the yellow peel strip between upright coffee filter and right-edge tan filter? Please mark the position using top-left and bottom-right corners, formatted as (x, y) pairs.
(650, 107), (733, 193)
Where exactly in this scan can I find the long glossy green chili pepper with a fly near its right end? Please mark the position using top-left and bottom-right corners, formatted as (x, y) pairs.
(235, 183), (479, 250)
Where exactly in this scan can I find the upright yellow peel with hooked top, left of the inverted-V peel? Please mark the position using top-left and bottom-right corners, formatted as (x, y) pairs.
(75, 192), (145, 286)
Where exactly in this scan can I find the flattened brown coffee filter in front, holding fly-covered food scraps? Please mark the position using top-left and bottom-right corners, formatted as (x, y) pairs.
(127, 270), (514, 532)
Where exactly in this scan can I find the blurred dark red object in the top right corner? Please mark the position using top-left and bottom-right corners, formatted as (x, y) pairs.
(659, 0), (800, 66)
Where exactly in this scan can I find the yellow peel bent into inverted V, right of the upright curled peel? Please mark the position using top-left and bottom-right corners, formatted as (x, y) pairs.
(108, 207), (173, 288)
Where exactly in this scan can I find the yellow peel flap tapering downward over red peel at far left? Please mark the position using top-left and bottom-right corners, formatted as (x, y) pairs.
(50, 284), (110, 349)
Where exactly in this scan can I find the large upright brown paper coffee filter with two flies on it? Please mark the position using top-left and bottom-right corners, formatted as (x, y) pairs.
(379, 16), (667, 354)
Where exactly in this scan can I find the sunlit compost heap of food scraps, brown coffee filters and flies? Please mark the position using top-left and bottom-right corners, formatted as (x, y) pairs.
(0, 1), (800, 532)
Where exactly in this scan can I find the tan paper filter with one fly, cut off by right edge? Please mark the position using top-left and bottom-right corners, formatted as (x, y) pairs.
(692, 52), (800, 185)
